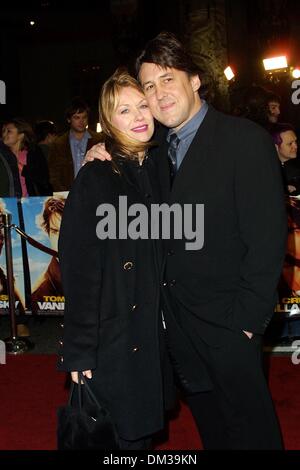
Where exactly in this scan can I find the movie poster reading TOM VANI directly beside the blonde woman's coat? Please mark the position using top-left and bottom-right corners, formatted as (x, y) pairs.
(22, 196), (66, 315)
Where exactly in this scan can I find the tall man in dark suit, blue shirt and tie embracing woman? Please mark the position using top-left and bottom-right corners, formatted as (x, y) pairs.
(86, 33), (287, 449)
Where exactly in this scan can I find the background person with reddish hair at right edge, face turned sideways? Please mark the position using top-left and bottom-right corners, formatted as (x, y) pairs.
(272, 123), (300, 196)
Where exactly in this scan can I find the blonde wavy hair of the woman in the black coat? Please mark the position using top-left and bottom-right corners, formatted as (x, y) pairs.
(99, 68), (155, 160)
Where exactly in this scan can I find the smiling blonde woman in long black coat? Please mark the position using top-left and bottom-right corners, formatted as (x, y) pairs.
(59, 71), (175, 449)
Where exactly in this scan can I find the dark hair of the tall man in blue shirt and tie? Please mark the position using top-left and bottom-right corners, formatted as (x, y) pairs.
(135, 31), (200, 76)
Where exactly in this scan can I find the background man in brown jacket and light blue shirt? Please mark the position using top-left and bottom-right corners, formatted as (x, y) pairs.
(49, 98), (100, 192)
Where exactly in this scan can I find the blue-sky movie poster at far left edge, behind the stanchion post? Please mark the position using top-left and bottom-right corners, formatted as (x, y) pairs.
(0, 198), (25, 314)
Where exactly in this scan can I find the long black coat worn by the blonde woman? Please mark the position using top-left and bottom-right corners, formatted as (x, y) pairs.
(59, 159), (171, 440)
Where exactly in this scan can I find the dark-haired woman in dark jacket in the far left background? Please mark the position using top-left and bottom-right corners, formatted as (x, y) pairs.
(1, 118), (52, 197)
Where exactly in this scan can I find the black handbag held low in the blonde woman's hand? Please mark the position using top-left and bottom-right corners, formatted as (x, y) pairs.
(57, 372), (119, 450)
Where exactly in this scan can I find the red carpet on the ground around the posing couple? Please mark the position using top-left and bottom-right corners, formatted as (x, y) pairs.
(0, 355), (300, 450)
